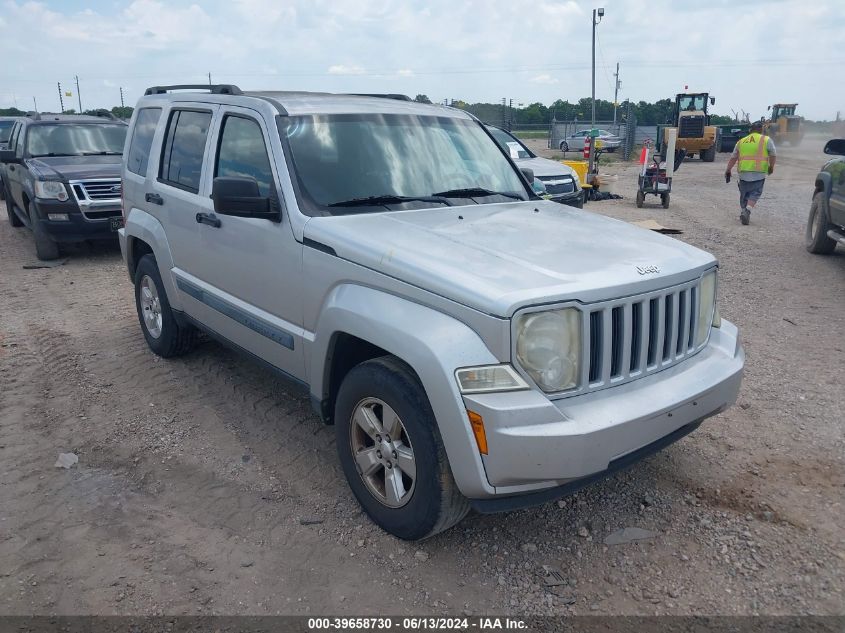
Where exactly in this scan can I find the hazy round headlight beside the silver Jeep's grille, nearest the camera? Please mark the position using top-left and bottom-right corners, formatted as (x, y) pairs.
(516, 308), (581, 392)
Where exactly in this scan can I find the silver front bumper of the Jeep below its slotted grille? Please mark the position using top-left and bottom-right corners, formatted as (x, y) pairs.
(464, 320), (745, 509)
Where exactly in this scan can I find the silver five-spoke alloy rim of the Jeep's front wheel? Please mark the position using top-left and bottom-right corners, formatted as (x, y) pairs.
(349, 398), (417, 508)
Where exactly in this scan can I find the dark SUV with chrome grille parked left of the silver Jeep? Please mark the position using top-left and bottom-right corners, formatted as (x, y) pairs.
(0, 111), (128, 260)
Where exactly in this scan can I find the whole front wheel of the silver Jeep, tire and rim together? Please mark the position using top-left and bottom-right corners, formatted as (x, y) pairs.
(334, 356), (469, 540)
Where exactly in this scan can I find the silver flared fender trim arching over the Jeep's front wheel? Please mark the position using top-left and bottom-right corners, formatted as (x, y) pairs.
(309, 284), (499, 497)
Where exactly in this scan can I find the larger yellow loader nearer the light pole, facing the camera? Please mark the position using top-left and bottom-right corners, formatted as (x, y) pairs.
(657, 92), (719, 163)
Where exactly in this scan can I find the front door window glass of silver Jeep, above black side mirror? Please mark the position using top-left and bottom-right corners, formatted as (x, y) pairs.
(214, 116), (273, 196)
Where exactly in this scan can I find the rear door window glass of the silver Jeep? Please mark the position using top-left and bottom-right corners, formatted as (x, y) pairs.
(159, 110), (211, 193)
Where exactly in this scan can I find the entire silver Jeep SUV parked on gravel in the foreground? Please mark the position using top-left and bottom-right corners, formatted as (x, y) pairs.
(119, 85), (744, 539)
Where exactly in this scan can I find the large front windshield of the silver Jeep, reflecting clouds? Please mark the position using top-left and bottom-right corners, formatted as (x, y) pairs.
(279, 114), (530, 215)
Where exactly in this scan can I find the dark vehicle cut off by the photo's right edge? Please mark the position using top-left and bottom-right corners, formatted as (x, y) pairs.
(805, 138), (845, 254)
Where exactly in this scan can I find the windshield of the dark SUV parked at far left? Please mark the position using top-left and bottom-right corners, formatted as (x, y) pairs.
(27, 123), (128, 158)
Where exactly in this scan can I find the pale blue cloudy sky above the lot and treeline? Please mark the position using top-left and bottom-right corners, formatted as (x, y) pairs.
(0, 0), (845, 120)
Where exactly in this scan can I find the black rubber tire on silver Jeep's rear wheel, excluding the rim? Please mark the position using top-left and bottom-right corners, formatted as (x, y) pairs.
(135, 254), (197, 358)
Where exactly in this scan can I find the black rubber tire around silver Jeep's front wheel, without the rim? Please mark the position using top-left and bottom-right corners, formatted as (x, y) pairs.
(334, 356), (469, 541)
